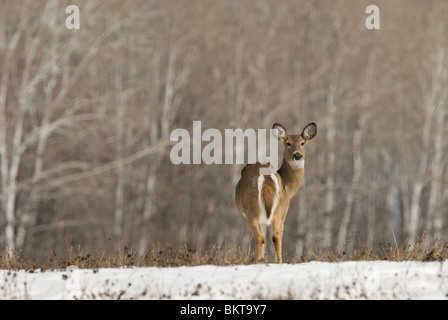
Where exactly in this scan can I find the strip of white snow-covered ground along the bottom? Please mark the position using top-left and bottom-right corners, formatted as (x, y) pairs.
(0, 261), (448, 299)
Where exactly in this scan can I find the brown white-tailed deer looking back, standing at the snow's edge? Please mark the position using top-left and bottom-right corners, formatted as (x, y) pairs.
(235, 122), (317, 263)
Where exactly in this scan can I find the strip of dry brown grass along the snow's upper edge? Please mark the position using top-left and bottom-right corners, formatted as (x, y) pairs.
(0, 240), (448, 270)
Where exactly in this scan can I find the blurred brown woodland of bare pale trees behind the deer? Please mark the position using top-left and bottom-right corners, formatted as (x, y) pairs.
(0, 0), (448, 256)
